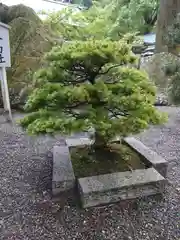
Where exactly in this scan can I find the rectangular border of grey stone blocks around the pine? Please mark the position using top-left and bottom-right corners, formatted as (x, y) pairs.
(52, 137), (167, 208)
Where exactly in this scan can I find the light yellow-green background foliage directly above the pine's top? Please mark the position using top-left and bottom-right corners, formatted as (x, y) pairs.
(44, 4), (112, 41)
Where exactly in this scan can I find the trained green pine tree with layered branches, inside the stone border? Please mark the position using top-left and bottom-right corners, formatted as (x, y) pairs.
(21, 41), (163, 148)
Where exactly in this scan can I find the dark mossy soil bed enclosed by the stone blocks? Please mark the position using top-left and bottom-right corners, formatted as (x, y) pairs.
(70, 143), (147, 177)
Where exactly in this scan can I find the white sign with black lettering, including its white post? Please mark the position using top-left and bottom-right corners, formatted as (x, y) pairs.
(0, 22), (12, 121)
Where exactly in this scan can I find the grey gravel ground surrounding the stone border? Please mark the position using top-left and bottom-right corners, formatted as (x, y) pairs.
(0, 107), (180, 240)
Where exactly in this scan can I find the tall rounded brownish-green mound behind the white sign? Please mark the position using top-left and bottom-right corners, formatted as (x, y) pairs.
(0, 4), (53, 108)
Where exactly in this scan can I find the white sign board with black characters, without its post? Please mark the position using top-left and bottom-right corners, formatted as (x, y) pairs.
(0, 22), (11, 68)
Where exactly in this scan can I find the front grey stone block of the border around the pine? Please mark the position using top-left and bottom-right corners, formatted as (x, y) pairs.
(78, 167), (167, 208)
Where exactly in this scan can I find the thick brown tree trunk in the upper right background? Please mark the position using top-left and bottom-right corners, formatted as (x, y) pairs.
(156, 0), (180, 53)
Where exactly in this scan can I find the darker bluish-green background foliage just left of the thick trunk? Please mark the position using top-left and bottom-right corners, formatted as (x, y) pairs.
(110, 0), (159, 39)
